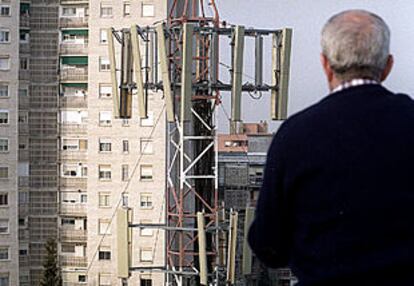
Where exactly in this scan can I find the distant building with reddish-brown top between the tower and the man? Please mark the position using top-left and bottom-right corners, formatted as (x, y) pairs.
(218, 122), (295, 286)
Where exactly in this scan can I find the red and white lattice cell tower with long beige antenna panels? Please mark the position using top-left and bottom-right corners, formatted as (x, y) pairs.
(108, 0), (292, 286)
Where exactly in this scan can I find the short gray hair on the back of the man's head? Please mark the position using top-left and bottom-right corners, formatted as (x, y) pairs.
(321, 10), (390, 81)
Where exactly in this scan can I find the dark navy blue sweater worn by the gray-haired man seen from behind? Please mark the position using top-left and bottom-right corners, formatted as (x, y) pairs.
(249, 85), (414, 286)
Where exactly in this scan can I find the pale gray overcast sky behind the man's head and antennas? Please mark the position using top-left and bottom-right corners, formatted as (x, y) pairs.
(216, 0), (414, 130)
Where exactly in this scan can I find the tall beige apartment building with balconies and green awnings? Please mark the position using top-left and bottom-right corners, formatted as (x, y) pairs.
(0, 0), (168, 286)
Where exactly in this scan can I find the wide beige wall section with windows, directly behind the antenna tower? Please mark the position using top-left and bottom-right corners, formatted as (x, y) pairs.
(87, 0), (167, 285)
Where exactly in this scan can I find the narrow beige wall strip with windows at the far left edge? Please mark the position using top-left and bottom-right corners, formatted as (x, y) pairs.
(0, 0), (20, 285)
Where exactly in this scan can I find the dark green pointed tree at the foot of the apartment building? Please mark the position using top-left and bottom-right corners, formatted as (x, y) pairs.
(40, 238), (62, 286)
